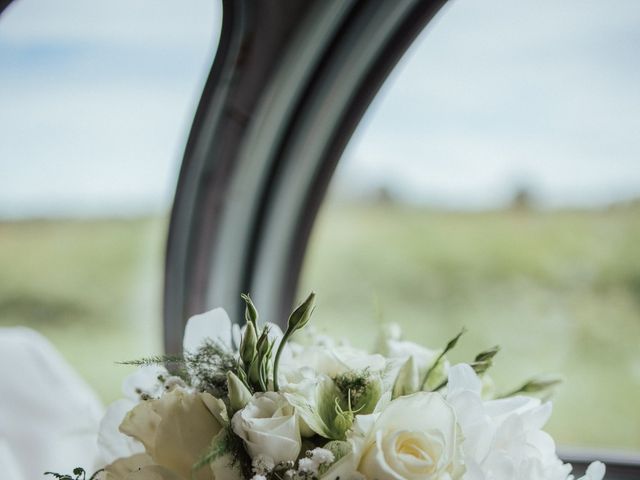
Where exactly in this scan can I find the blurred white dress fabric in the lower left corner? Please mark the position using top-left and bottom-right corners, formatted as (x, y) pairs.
(0, 327), (103, 480)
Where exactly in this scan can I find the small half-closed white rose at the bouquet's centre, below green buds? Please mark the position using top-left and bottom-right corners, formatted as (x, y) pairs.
(231, 392), (302, 463)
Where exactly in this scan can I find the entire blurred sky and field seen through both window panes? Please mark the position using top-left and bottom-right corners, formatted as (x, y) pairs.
(0, 0), (640, 451)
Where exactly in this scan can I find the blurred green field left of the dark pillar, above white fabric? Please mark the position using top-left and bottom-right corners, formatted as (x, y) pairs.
(0, 220), (166, 402)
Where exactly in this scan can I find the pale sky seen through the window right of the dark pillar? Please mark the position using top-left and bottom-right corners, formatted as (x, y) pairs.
(337, 0), (640, 209)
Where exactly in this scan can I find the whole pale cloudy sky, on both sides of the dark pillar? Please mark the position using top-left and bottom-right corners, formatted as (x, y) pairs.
(0, 0), (640, 218)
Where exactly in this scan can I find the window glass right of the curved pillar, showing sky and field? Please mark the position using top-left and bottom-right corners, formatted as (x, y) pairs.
(300, 0), (640, 451)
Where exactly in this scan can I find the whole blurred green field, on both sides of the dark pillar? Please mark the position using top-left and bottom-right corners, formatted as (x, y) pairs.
(0, 204), (640, 450)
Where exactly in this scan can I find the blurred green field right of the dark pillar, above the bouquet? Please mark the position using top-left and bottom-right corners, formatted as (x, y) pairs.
(300, 204), (640, 450)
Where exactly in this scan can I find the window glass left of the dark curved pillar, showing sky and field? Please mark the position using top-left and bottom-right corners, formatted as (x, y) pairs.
(0, 0), (221, 401)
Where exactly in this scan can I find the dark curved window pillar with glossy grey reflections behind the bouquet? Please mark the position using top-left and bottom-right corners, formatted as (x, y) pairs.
(164, 0), (445, 352)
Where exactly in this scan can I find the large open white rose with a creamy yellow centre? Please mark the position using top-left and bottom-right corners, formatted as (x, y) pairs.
(351, 392), (465, 480)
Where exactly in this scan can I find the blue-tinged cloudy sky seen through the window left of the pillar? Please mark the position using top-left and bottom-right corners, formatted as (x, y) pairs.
(0, 0), (220, 217)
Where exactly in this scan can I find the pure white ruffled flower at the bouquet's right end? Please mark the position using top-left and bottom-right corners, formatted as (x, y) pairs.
(446, 364), (571, 480)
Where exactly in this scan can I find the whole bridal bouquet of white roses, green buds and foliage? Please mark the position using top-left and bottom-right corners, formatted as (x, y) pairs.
(53, 294), (605, 480)
